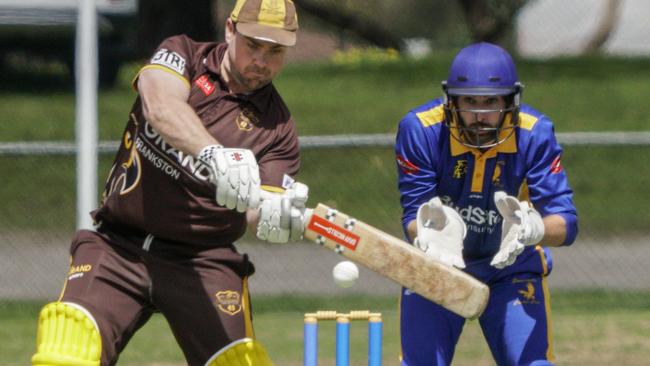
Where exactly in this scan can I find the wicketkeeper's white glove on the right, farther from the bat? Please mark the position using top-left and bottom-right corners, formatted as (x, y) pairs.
(490, 191), (544, 269)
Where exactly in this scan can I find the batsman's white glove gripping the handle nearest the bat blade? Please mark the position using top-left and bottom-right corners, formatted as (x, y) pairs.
(257, 182), (311, 243)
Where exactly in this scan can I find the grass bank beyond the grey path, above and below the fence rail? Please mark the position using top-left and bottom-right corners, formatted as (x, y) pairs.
(0, 54), (650, 236)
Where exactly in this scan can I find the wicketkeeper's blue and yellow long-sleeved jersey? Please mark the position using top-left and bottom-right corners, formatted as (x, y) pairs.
(395, 98), (577, 260)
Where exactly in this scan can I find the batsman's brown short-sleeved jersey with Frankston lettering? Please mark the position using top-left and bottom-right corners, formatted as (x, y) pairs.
(92, 36), (300, 246)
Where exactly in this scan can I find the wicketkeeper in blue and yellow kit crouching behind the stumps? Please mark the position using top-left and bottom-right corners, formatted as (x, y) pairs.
(395, 43), (578, 366)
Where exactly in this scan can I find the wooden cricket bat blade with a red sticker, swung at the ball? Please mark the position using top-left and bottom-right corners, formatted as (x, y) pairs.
(304, 203), (489, 319)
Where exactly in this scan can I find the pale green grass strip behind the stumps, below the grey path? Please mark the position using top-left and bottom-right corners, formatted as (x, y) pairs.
(0, 291), (650, 366)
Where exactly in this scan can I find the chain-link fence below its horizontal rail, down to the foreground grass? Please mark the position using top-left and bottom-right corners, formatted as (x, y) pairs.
(0, 132), (650, 299)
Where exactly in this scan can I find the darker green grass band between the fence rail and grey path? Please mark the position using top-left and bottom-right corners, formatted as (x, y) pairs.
(0, 143), (650, 236)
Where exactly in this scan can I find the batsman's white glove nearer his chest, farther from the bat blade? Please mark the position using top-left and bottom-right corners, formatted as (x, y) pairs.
(198, 145), (260, 212)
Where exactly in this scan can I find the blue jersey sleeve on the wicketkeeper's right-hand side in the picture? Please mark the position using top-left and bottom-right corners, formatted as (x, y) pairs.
(522, 116), (578, 245)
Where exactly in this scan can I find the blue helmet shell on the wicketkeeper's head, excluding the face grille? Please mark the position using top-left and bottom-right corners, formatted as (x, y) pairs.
(443, 42), (521, 96)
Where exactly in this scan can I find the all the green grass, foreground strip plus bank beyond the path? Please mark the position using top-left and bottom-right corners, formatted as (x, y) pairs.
(0, 55), (650, 366)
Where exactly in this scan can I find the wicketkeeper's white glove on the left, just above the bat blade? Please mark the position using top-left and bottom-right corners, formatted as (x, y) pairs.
(413, 197), (467, 268)
